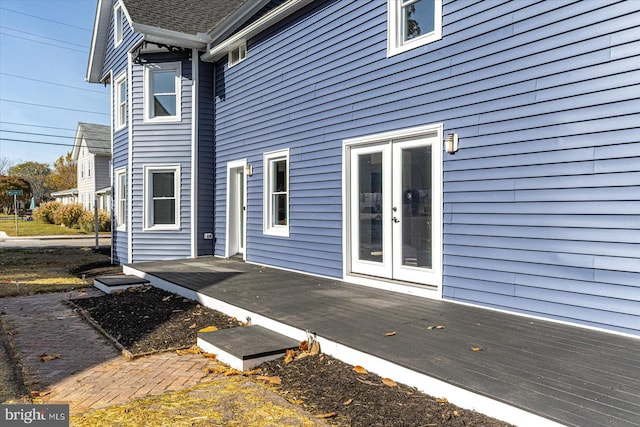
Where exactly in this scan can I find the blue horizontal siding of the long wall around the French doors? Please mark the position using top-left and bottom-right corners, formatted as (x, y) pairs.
(215, 0), (640, 334)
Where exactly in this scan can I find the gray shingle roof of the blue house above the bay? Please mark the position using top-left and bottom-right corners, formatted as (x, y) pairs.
(124, 0), (249, 35)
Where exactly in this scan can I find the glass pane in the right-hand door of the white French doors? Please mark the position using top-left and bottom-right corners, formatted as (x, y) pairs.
(401, 146), (433, 268)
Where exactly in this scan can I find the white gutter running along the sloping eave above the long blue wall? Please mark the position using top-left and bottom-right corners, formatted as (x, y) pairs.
(200, 0), (313, 62)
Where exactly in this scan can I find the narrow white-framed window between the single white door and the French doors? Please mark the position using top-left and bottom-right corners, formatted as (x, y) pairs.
(263, 150), (289, 237)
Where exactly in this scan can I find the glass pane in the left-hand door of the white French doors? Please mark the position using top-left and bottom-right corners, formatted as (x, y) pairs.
(358, 153), (383, 262)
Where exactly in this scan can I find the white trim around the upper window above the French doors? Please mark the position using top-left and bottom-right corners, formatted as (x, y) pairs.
(387, 0), (442, 57)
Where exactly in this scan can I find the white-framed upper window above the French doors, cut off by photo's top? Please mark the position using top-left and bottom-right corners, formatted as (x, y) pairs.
(387, 0), (442, 56)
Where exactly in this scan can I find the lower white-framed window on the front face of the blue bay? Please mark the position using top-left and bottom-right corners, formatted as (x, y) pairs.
(144, 165), (180, 230)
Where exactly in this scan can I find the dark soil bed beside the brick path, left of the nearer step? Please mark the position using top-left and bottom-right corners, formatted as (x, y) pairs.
(71, 286), (242, 356)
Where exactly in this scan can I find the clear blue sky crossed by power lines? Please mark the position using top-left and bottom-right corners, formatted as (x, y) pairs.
(0, 0), (110, 169)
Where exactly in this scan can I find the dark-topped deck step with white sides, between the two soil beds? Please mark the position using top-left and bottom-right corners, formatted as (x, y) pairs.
(198, 325), (300, 371)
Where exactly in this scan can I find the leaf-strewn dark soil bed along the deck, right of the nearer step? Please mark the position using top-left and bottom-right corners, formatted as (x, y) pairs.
(261, 354), (508, 427)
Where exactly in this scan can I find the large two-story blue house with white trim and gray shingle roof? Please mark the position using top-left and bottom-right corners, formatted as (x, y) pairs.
(87, 0), (640, 335)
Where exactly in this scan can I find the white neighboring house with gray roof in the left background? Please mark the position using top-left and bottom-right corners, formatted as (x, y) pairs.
(72, 123), (111, 211)
